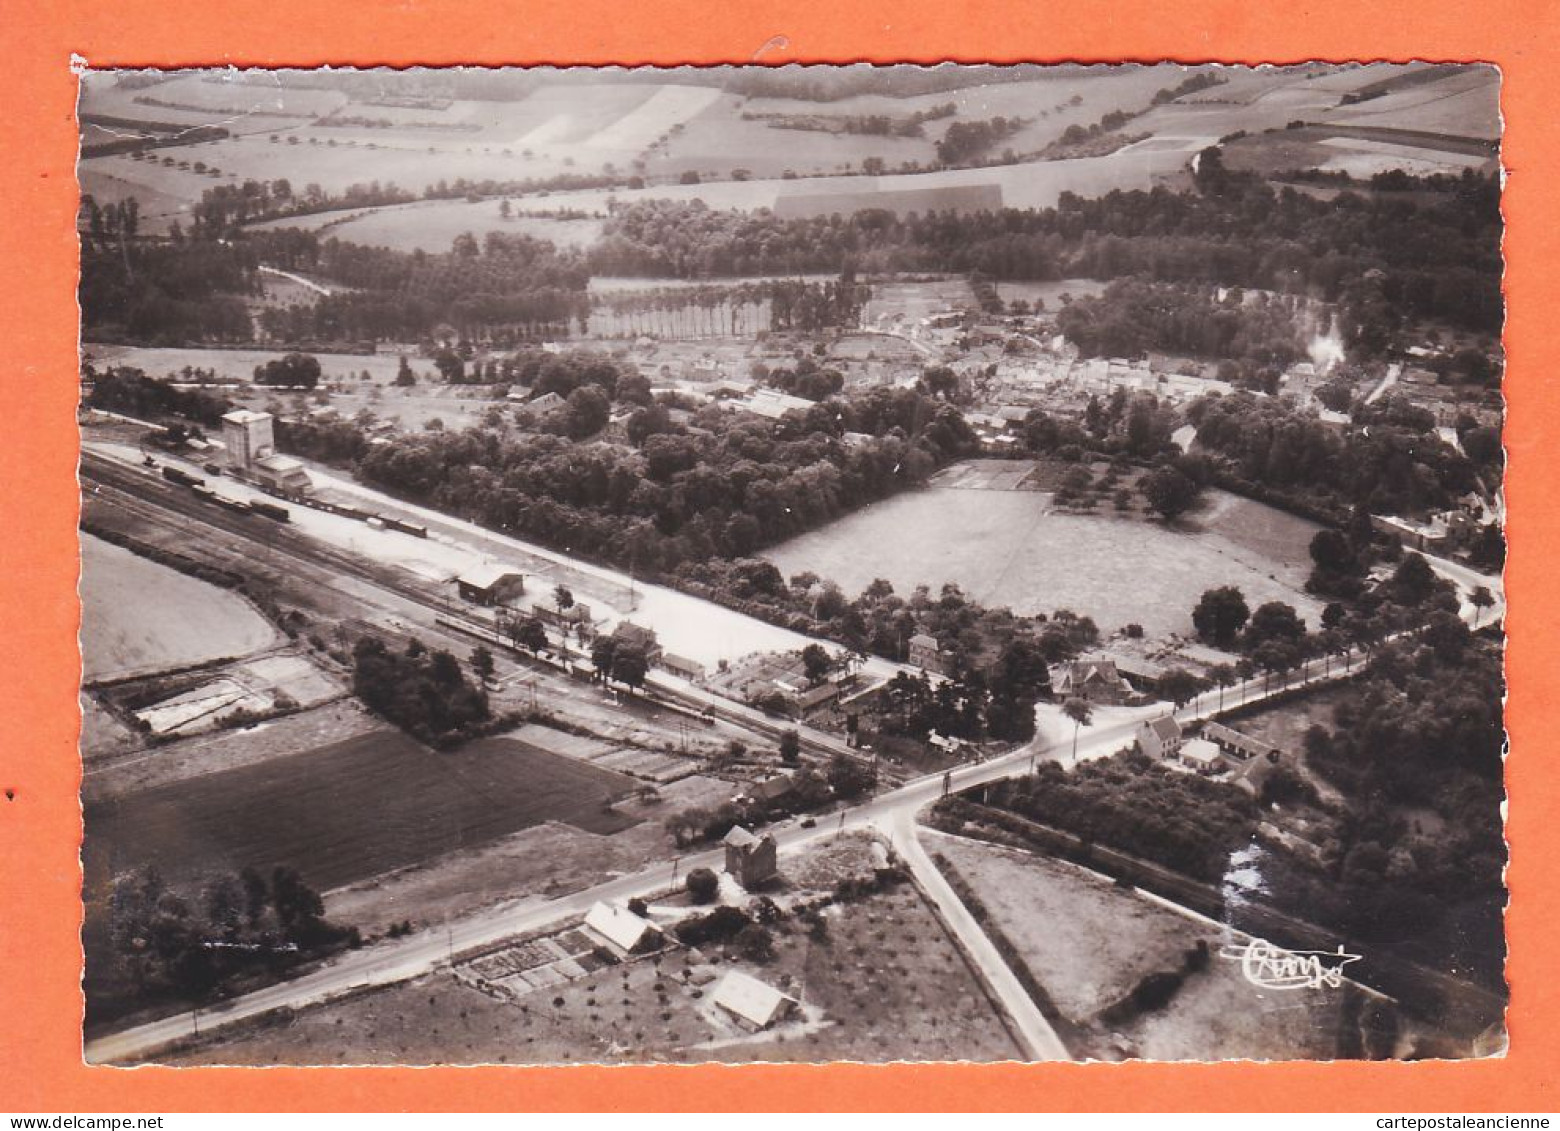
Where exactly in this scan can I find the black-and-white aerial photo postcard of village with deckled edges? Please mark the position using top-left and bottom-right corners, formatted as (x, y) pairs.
(78, 62), (1509, 1065)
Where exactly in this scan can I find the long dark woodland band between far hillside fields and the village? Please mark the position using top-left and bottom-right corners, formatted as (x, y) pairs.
(588, 164), (1504, 347)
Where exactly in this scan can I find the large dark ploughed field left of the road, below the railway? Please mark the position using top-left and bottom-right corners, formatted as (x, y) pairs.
(84, 729), (635, 889)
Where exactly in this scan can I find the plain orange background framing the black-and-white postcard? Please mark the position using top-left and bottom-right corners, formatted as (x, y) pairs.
(0, 0), (1560, 1112)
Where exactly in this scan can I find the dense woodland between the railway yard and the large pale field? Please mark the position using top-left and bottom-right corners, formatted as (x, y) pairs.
(357, 377), (975, 574)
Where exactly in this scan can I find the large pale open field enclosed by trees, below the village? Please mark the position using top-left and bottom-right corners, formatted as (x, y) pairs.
(763, 473), (1321, 638)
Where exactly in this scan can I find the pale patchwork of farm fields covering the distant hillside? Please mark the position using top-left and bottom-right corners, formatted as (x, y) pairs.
(81, 64), (1499, 250)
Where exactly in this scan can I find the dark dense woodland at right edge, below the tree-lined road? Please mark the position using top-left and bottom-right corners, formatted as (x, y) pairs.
(1295, 636), (1505, 983)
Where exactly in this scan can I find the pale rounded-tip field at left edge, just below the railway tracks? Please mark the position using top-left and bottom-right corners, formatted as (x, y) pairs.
(81, 534), (279, 683)
